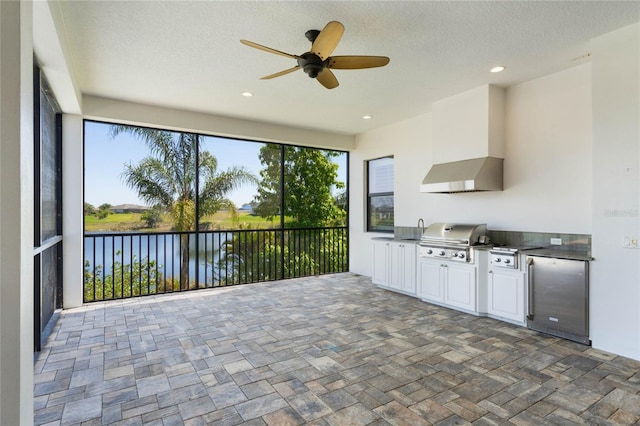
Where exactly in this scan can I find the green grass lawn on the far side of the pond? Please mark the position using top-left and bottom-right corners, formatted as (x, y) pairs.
(84, 212), (278, 232)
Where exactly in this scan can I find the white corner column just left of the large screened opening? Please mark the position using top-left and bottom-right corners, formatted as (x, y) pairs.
(62, 114), (84, 309)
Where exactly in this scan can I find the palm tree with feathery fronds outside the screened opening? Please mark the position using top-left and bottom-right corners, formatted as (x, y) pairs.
(110, 125), (257, 290)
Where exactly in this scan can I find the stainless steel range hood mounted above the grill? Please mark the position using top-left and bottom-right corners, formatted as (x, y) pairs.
(420, 157), (503, 193)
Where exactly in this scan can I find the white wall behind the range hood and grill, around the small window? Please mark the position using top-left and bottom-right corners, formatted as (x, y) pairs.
(349, 64), (592, 276)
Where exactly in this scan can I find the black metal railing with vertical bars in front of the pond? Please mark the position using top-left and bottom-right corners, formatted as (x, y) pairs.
(83, 227), (348, 302)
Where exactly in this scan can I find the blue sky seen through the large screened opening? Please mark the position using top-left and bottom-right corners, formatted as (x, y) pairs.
(84, 121), (347, 207)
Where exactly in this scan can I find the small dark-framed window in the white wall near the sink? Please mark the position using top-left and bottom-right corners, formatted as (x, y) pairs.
(367, 157), (393, 232)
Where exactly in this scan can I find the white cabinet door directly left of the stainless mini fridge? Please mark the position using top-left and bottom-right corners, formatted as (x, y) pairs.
(488, 270), (524, 324)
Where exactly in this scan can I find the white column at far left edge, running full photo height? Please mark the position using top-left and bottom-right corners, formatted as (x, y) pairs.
(0, 1), (34, 425)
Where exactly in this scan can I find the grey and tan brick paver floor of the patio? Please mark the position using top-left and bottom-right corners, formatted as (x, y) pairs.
(34, 273), (640, 425)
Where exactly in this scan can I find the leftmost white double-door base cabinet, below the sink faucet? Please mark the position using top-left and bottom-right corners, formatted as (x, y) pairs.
(372, 241), (416, 296)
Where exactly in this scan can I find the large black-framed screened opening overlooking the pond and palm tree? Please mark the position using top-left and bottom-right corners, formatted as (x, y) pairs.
(84, 121), (348, 302)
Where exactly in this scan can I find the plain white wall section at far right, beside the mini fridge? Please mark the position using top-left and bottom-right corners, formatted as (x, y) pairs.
(590, 24), (640, 359)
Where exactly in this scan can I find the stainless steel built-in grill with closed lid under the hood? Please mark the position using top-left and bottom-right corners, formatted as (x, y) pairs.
(420, 223), (488, 263)
